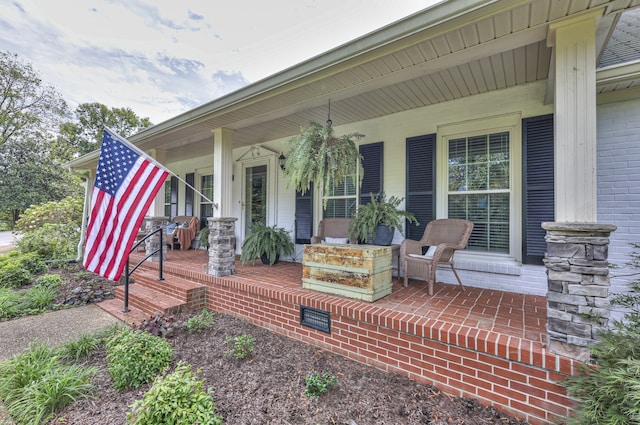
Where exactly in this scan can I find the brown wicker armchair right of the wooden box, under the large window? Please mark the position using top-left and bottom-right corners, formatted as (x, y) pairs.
(400, 218), (473, 295)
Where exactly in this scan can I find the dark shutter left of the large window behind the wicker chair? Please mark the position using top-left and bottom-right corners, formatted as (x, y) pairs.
(405, 134), (436, 240)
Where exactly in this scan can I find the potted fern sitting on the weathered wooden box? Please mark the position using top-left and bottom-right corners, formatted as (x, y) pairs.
(349, 193), (419, 246)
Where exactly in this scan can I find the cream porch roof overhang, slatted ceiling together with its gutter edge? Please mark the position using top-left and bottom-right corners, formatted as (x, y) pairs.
(76, 0), (640, 167)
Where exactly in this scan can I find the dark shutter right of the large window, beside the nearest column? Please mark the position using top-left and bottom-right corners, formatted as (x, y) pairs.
(522, 115), (555, 264)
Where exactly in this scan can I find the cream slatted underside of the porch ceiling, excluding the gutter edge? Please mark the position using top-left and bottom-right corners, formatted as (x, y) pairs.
(132, 0), (639, 161)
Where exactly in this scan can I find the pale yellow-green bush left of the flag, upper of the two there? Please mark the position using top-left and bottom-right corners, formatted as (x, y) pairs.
(15, 196), (83, 233)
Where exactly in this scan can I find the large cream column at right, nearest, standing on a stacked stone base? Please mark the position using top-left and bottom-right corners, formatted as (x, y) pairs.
(547, 11), (602, 223)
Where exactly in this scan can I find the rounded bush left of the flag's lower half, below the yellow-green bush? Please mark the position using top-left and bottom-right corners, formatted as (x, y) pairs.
(18, 223), (80, 260)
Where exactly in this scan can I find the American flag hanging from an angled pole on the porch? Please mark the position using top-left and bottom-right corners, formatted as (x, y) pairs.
(83, 129), (169, 281)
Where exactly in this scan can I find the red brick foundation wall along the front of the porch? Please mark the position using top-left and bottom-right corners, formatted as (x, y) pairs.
(182, 275), (578, 425)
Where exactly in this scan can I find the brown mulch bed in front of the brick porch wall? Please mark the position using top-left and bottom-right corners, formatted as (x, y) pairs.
(51, 308), (526, 425)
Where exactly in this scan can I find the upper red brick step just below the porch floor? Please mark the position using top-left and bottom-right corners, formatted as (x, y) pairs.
(133, 270), (207, 309)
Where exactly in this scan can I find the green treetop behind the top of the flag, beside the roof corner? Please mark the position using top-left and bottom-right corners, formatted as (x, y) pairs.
(59, 102), (152, 155)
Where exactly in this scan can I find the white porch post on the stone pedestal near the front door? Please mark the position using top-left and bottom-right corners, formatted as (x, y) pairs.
(213, 128), (233, 218)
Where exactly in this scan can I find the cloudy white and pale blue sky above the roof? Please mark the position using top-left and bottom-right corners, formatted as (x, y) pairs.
(0, 0), (437, 124)
